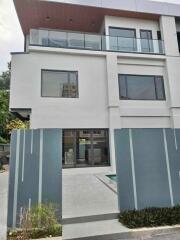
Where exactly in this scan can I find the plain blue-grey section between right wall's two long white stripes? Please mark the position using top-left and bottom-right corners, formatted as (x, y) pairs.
(132, 129), (171, 209)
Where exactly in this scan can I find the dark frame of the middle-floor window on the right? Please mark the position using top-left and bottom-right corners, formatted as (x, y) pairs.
(118, 73), (166, 101)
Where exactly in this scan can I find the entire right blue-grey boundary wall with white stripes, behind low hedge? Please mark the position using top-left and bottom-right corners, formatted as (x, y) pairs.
(115, 129), (180, 211)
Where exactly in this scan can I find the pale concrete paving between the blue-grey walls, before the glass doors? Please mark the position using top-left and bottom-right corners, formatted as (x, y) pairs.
(63, 168), (118, 218)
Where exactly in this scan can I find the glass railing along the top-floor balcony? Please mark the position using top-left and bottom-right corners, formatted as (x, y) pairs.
(30, 29), (165, 54)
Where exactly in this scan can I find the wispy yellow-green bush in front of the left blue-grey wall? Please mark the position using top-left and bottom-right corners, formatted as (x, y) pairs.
(8, 204), (62, 240)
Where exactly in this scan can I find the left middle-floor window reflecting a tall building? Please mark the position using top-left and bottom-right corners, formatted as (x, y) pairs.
(41, 70), (78, 98)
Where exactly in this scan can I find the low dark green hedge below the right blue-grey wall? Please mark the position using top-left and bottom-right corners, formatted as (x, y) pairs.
(119, 206), (180, 228)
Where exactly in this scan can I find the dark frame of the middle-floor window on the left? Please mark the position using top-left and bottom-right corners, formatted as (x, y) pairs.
(41, 69), (79, 99)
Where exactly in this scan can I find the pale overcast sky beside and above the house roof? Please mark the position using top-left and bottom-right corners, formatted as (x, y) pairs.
(0, 0), (180, 74)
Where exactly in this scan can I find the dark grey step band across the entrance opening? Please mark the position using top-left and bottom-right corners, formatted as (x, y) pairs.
(62, 212), (119, 225)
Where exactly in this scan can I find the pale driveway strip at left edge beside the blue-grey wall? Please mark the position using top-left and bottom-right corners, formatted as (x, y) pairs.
(0, 172), (8, 240)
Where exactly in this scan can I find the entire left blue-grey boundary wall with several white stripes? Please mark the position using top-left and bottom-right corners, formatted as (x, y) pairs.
(8, 129), (62, 228)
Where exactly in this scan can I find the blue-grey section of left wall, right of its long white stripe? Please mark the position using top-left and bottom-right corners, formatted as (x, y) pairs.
(42, 129), (62, 218)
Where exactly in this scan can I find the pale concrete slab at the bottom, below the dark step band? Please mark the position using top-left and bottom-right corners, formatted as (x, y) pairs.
(63, 219), (130, 240)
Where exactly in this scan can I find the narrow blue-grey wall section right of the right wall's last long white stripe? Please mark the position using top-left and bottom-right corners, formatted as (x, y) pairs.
(166, 129), (180, 205)
